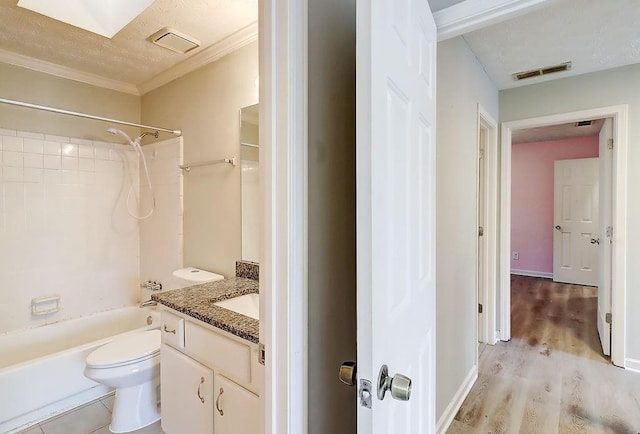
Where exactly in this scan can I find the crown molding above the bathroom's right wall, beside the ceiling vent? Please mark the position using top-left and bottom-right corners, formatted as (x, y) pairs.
(138, 21), (258, 95)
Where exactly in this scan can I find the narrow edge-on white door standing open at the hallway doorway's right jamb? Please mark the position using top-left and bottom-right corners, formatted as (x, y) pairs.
(598, 118), (613, 356)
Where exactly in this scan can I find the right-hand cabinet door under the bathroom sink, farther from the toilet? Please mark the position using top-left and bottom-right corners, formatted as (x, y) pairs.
(214, 375), (263, 434)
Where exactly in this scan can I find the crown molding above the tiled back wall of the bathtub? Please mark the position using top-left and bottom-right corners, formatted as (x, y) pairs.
(0, 49), (140, 96)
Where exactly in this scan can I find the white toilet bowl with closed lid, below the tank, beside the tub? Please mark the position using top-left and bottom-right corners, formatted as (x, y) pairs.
(84, 330), (160, 433)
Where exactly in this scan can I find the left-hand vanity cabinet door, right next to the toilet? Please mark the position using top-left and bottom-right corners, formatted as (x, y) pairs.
(160, 345), (213, 434)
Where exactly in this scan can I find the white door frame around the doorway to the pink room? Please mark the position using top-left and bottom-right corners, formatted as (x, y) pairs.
(499, 104), (629, 367)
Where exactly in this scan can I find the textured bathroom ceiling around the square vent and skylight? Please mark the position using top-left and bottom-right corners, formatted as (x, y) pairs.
(0, 0), (258, 85)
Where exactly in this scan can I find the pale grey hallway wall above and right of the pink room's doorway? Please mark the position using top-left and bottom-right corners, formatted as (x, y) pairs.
(500, 64), (640, 366)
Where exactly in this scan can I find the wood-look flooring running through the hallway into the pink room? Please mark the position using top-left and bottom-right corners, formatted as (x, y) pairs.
(447, 276), (640, 434)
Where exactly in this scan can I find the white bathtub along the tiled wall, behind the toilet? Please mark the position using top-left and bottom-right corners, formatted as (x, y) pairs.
(0, 306), (160, 433)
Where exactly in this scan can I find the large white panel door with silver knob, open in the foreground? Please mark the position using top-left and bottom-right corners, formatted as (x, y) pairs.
(356, 0), (436, 434)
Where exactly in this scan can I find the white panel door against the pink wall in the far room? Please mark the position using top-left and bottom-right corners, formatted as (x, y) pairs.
(553, 158), (600, 286)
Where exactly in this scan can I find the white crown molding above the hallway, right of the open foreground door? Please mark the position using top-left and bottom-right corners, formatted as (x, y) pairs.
(433, 0), (557, 41)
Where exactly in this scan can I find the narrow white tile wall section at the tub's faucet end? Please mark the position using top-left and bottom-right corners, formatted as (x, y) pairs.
(138, 137), (183, 300)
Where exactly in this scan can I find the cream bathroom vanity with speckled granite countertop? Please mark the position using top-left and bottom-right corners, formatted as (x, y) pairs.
(153, 278), (264, 434)
